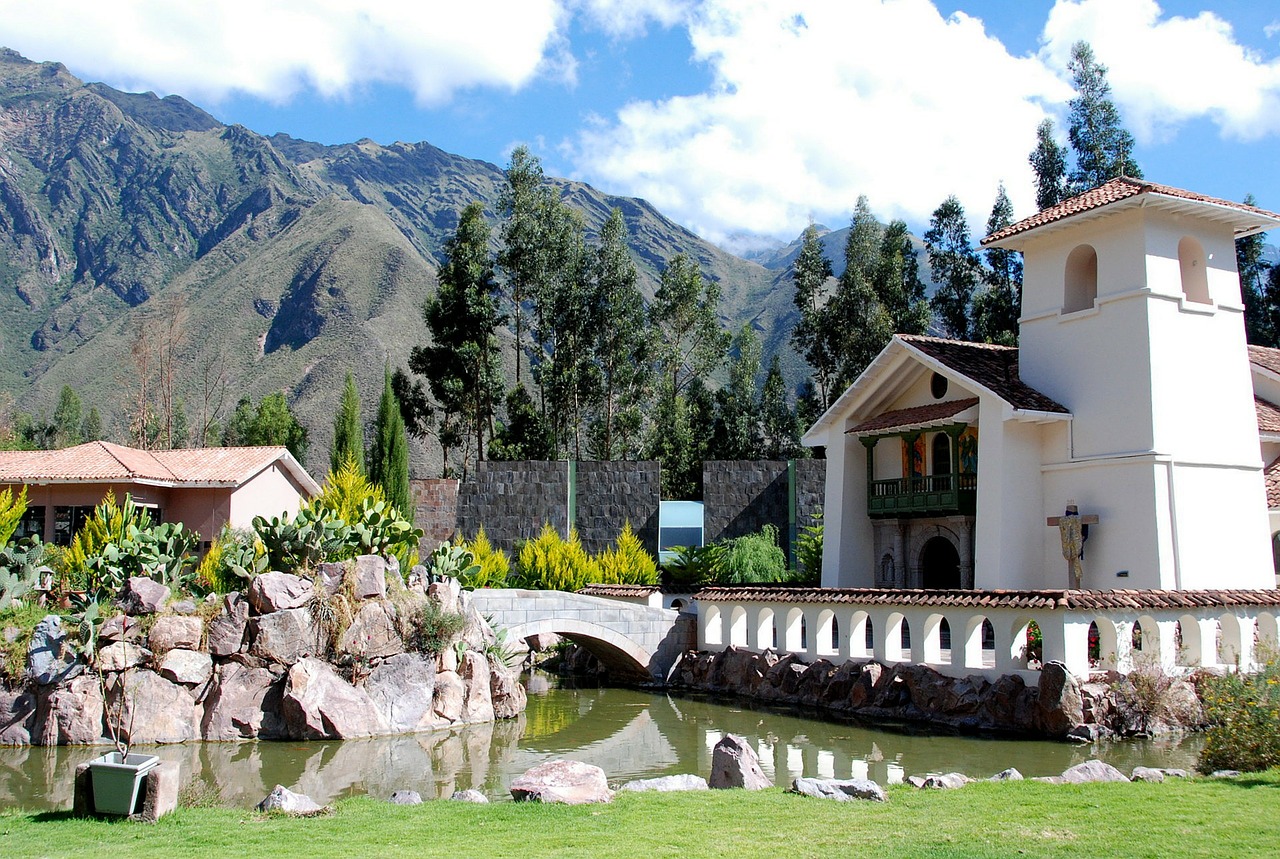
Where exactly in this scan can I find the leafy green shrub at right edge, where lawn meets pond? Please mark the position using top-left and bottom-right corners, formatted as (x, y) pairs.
(1197, 653), (1280, 772)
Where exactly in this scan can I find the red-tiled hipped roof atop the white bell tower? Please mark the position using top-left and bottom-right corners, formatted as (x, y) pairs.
(982, 177), (1280, 247)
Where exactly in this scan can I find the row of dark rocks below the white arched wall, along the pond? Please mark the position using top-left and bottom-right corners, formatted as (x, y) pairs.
(673, 646), (1203, 739)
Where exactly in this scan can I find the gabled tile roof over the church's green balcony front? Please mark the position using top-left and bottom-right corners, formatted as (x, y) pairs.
(803, 334), (1071, 444)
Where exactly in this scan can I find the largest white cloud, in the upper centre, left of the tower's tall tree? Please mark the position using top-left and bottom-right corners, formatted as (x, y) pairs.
(575, 0), (1070, 241)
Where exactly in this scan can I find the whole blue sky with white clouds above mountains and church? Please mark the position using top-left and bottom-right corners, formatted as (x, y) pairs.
(0, 0), (1280, 248)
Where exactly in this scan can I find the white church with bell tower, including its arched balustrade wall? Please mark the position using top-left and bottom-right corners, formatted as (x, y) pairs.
(698, 177), (1280, 680)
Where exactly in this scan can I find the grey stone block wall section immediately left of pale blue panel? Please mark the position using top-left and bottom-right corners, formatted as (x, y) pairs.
(575, 462), (662, 557)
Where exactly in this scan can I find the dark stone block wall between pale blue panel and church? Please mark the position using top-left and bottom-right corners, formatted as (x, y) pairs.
(703, 460), (827, 563)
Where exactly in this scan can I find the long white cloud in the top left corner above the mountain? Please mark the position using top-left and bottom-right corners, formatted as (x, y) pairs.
(0, 0), (573, 105)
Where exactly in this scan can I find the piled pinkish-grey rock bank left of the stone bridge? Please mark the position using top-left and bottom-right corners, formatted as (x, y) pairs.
(0, 556), (527, 745)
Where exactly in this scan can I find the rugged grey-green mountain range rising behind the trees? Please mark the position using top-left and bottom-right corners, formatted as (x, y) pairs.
(0, 49), (801, 475)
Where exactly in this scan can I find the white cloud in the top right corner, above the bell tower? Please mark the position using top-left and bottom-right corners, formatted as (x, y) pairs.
(1042, 0), (1280, 142)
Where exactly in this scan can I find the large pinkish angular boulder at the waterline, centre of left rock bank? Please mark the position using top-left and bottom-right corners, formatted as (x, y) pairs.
(280, 657), (389, 740)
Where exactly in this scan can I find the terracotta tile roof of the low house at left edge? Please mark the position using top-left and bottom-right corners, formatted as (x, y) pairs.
(0, 442), (320, 495)
